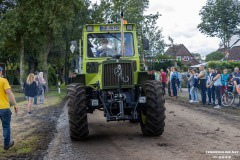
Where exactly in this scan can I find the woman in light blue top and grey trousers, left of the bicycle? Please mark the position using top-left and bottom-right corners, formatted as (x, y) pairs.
(210, 68), (222, 108)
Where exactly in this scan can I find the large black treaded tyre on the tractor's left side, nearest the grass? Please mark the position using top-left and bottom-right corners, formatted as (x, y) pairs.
(67, 83), (89, 140)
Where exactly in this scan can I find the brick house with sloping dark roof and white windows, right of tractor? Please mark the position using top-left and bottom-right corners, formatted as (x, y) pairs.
(164, 44), (199, 66)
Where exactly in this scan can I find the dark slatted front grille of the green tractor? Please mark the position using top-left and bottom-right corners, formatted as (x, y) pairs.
(103, 63), (133, 88)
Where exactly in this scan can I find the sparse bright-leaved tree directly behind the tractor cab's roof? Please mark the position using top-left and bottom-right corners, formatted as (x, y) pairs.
(104, 0), (165, 54)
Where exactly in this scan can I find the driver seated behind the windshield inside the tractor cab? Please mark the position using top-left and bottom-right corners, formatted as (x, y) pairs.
(96, 39), (113, 57)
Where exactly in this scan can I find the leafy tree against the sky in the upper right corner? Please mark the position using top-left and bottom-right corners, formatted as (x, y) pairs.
(198, 0), (240, 57)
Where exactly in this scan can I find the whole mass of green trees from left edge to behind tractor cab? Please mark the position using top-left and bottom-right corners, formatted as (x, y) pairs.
(0, 0), (164, 87)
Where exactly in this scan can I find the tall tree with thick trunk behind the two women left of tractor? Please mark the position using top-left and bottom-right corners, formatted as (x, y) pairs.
(23, 0), (86, 89)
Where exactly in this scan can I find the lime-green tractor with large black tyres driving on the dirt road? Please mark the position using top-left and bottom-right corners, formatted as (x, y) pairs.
(67, 23), (165, 140)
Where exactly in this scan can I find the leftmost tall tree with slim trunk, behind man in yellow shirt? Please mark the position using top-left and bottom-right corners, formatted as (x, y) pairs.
(0, 0), (29, 89)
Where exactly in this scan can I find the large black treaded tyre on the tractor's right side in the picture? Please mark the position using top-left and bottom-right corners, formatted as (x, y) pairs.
(139, 80), (166, 136)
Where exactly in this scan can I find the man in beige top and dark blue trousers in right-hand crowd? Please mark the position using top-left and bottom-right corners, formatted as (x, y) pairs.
(198, 65), (207, 106)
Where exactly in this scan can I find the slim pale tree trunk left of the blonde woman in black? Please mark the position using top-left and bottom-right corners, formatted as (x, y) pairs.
(20, 35), (25, 91)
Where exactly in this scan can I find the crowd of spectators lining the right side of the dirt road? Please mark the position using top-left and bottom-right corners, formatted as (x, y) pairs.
(149, 65), (240, 108)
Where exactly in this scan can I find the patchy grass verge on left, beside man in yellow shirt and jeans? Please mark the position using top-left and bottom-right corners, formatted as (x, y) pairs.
(0, 87), (66, 160)
